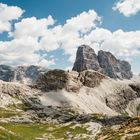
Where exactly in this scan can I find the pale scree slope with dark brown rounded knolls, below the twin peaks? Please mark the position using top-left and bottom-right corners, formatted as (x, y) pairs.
(34, 70), (140, 115)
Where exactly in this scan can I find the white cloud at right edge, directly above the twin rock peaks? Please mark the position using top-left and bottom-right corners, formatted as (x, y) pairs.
(85, 28), (140, 58)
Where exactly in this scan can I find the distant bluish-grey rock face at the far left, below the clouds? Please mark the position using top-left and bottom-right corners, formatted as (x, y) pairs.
(0, 65), (47, 84)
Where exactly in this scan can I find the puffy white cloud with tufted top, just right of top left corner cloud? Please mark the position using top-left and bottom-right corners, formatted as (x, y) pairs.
(10, 16), (55, 38)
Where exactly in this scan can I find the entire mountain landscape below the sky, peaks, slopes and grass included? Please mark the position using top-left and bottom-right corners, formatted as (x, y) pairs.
(0, 46), (140, 140)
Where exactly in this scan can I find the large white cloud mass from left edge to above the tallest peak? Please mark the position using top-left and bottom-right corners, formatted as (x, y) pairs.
(0, 10), (101, 66)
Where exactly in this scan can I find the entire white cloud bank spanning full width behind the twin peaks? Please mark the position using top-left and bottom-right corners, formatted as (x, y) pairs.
(0, 2), (140, 67)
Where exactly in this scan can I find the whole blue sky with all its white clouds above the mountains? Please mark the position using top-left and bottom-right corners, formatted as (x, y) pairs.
(0, 0), (140, 73)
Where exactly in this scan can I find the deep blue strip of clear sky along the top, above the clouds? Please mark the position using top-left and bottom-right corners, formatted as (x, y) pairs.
(0, 0), (140, 31)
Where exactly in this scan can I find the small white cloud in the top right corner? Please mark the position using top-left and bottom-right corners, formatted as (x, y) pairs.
(113, 0), (140, 17)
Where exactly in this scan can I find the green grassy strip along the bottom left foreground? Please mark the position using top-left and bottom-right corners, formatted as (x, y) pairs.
(0, 123), (88, 140)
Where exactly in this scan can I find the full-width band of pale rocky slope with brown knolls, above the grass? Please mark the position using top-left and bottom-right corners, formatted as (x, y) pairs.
(0, 70), (140, 116)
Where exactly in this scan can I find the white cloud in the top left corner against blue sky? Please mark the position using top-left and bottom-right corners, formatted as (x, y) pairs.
(0, 3), (24, 33)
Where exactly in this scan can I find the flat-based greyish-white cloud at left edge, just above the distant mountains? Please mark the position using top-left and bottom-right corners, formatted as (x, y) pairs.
(0, 37), (54, 66)
